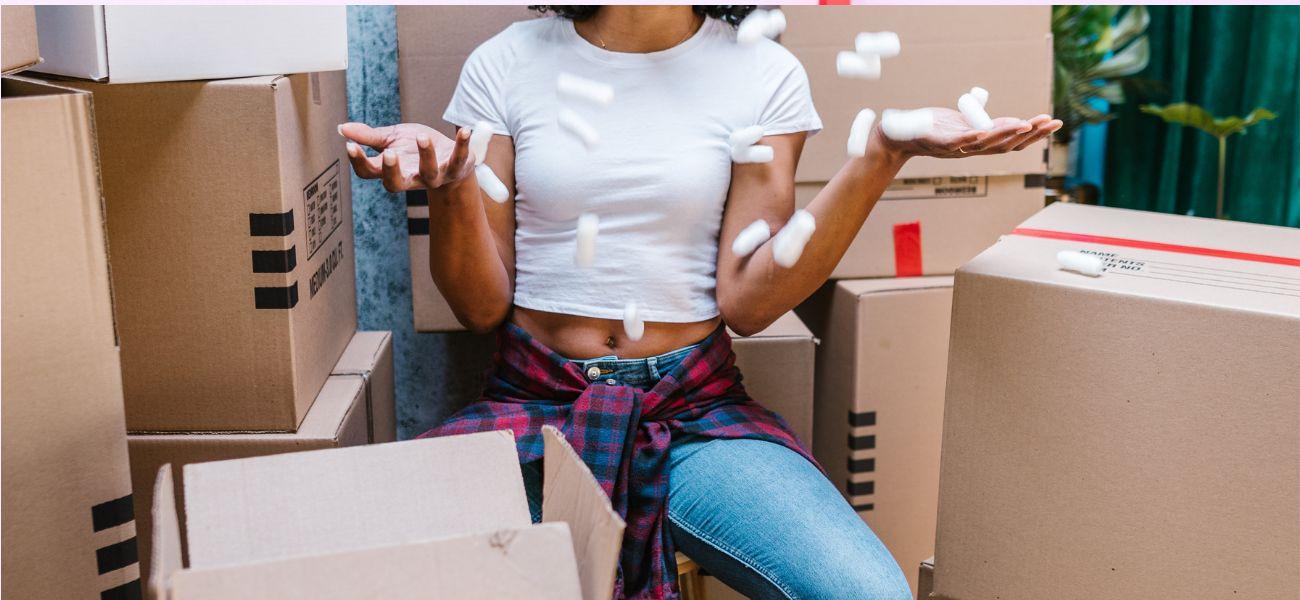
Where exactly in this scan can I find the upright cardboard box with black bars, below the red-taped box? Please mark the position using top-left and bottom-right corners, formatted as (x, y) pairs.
(800, 277), (953, 590)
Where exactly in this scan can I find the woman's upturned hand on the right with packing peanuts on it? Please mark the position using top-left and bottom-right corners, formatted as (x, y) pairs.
(871, 108), (1062, 158)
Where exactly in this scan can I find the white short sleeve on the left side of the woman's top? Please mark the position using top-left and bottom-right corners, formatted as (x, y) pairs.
(442, 29), (514, 135)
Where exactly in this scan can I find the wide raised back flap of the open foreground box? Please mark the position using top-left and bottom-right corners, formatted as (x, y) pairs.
(183, 431), (532, 568)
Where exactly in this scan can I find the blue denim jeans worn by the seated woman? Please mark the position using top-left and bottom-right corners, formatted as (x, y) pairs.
(523, 347), (913, 600)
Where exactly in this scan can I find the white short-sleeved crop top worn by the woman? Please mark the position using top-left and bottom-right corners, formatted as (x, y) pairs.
(443, 17), (822, 322)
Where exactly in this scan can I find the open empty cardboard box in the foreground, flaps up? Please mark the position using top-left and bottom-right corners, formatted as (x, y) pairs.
(150, 427), (624, 600)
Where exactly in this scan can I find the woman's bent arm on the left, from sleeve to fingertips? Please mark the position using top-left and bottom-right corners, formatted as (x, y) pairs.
(339, 123), (515, 332)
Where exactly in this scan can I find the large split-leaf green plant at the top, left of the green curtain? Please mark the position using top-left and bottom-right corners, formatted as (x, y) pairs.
(1052, 5), (1151, 140)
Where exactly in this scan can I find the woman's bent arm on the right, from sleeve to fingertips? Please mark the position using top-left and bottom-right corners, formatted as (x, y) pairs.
(716, 109), (1060, 335)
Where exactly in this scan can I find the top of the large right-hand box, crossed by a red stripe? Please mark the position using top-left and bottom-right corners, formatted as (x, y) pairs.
(958, 203), (1300, 317)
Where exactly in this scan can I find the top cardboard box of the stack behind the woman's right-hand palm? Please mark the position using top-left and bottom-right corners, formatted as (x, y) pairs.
(781, 5), (1053, 182)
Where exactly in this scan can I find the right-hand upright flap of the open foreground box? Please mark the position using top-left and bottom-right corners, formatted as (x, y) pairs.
(542, 426), (624, 600)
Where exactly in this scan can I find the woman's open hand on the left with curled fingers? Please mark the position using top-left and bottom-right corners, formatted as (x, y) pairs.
(338, 123), (475, 192)
